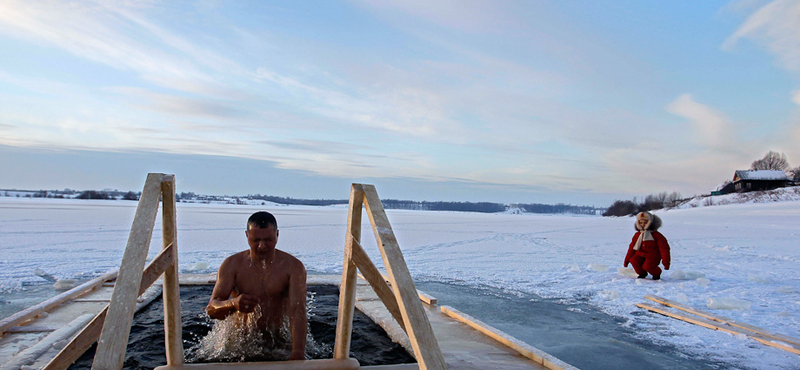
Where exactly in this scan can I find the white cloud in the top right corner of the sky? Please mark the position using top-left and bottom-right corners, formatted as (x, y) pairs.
(722, 0), (800, 72)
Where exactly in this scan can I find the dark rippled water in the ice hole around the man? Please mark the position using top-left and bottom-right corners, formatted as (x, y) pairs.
(70, 285), (416, 370)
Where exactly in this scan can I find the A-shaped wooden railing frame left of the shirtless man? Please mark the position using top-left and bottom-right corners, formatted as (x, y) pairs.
(38, 173), (184, 370)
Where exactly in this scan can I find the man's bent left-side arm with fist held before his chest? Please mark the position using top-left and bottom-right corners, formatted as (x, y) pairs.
(206, 256), (258, 320)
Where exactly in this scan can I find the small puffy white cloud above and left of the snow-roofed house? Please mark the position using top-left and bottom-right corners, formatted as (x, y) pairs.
(667, 94), (733, 149)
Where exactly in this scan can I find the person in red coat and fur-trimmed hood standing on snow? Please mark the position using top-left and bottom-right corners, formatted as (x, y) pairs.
(623, 212), (669, 280)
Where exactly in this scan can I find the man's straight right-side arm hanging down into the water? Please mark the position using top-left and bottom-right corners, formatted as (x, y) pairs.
(287, 260), (308, 360)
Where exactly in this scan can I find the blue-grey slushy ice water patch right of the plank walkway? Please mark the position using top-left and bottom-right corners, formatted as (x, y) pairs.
(416, 281), (741, 370)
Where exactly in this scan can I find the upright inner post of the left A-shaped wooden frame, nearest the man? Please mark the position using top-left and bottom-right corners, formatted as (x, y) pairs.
(161, 175), (184, 366)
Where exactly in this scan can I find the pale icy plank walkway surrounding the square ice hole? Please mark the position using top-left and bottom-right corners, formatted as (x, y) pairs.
(0, 274), (576, 370)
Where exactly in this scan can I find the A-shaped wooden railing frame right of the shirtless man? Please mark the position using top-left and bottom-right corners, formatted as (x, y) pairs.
(333, 184), (447, 370)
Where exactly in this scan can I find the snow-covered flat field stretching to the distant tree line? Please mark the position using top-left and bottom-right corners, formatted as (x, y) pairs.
(0, 197), (800, 369)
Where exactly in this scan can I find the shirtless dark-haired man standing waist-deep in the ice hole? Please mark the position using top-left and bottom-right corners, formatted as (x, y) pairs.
(206, 212), (308, 360)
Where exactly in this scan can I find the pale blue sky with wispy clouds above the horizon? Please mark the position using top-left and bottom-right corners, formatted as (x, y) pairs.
(0, 0), (800, 206)
